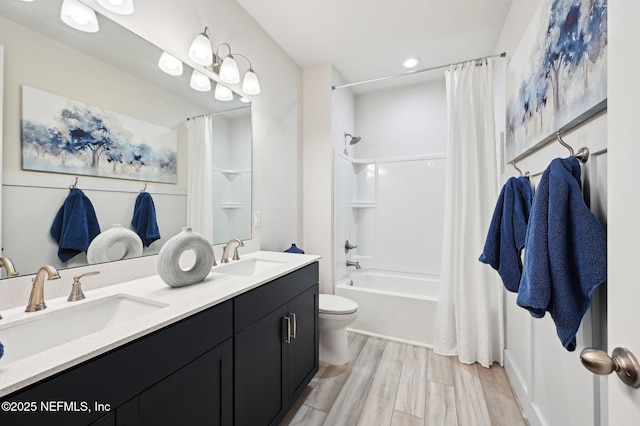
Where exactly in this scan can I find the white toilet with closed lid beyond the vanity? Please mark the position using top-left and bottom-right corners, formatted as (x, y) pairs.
(318, 294), (358, 365)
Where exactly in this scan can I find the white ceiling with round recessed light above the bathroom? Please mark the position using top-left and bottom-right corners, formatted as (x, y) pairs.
(236, 0), (513, 92)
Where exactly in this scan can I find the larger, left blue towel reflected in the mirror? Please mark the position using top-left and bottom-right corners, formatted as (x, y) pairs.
(49, 188), (100, 262)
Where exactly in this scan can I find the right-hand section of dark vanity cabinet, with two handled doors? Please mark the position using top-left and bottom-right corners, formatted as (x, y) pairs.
(234, 263), (318, 426)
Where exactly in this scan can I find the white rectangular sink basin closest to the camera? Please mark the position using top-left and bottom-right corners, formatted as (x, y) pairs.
(0, 294), (167, 366)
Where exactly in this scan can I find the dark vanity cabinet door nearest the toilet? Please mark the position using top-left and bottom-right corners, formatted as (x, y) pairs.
(288, 285), (318, 405)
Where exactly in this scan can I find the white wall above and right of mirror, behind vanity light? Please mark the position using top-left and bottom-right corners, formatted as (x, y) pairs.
(85, 0), (302, 253)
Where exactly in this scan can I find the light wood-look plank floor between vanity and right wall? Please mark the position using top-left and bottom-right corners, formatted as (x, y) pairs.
(281, 333), (528, 426)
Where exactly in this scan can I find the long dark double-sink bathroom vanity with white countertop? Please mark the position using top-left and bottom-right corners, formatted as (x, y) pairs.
(0, 252), (318, 426)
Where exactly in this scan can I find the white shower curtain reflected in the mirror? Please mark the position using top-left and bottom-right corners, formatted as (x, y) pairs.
(187, 117), (213, 242)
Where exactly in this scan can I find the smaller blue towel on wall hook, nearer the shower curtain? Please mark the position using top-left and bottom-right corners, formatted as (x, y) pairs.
(479, 176), (533, 292)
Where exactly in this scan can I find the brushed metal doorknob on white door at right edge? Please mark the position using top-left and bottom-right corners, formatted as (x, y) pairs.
(580, 348), (640, 388)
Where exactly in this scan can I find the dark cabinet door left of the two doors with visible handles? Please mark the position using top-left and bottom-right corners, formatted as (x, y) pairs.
(116, 339), (233, 426)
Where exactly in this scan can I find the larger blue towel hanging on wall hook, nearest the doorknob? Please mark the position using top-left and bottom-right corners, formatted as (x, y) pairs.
(517, 157), (607, 351)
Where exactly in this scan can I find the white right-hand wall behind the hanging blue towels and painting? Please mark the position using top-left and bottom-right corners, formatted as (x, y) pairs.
(495, 0), (607, 426)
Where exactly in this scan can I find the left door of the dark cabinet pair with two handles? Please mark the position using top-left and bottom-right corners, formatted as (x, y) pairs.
(235, 307), (288, 426)
